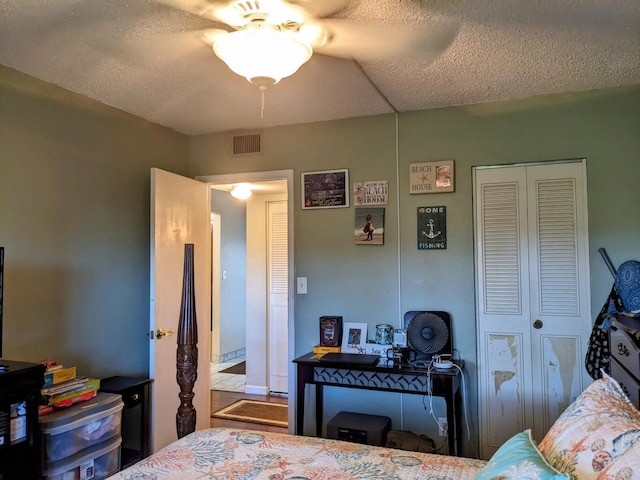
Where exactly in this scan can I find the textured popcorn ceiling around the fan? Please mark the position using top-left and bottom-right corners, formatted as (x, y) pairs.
(0, 0), (640, 135)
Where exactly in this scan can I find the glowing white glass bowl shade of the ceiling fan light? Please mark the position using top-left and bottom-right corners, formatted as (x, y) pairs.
(213, 27), (313, 88)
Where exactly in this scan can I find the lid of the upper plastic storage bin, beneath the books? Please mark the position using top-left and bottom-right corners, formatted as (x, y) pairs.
(38, 392), (124, 435)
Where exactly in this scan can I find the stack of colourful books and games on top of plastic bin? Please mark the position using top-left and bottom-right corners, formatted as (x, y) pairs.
(40, 361), (100, 415)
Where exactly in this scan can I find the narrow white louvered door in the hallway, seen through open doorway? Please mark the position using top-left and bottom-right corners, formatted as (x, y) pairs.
(267, 202), (289, 393)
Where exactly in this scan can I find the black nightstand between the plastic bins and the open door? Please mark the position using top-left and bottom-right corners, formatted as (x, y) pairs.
(100, 376), (153, 468)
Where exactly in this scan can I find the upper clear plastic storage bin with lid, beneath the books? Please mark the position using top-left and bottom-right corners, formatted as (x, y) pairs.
(39, 392), (124, 464)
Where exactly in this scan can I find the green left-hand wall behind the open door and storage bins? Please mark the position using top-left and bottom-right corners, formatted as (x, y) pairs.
(0, 66), (188, 377)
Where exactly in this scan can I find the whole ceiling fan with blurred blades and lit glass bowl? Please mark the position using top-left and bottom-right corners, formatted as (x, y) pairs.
(156, 0), (457, 90)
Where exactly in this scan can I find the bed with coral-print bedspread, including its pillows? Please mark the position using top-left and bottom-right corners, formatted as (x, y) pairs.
(110, 374), (640, 480)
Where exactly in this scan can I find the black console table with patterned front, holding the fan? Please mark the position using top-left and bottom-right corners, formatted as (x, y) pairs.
(293, 353), (464, 455)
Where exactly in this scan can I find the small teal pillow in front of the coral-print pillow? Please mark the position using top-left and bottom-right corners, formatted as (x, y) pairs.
(476, 430), (569, 480)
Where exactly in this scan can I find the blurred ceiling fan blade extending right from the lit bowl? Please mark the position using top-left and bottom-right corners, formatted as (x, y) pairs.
(317, 19), (459, 61)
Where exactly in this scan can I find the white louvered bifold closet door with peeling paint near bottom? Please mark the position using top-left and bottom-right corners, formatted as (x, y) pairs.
(474, 162), (591, 458)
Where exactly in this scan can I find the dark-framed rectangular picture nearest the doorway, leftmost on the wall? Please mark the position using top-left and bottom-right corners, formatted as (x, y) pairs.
(300, 169), (349, 210)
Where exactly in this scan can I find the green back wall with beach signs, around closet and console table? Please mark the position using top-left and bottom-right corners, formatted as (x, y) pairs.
(189, 87), (640, 454)
